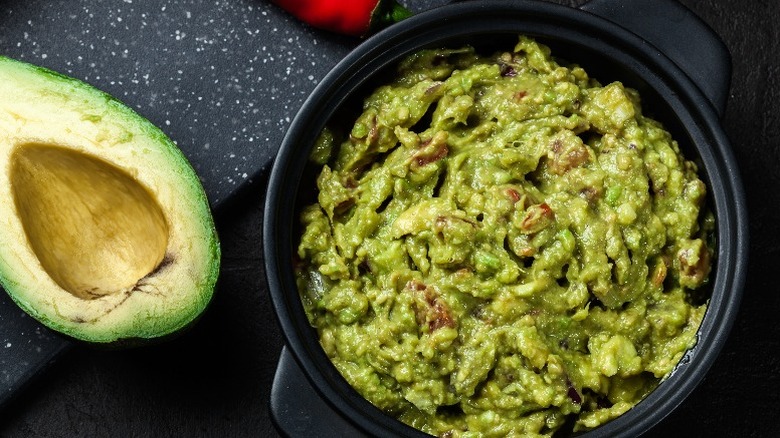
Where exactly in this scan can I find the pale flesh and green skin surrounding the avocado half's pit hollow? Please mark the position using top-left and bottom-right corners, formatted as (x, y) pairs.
(0, 56), (221, 348)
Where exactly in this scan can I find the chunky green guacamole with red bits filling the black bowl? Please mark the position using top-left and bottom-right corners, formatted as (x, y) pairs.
(296, 37), (714, 437)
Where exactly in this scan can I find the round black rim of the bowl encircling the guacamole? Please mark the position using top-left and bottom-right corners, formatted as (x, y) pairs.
(263, 0), (748, 436)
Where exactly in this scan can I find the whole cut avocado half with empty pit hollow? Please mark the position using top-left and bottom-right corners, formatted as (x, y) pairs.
(0, 57), (220, 344)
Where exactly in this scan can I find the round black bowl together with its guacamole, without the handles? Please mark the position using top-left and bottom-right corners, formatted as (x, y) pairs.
(264, 2), (747, 437)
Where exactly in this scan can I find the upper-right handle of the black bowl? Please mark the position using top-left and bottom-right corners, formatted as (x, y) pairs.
(580, 0), (731, 117)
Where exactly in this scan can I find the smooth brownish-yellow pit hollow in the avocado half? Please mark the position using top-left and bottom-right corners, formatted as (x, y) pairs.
(10, 144), (168, 299)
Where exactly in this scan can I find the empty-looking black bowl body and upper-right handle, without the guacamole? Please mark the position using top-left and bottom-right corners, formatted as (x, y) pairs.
(264, 0), (748, 436)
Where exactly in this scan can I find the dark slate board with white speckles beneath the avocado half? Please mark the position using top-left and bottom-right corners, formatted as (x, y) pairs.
(0, 0), (446, 406)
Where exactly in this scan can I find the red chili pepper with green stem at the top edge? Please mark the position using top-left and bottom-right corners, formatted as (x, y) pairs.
(272, 0), (412, 37)
